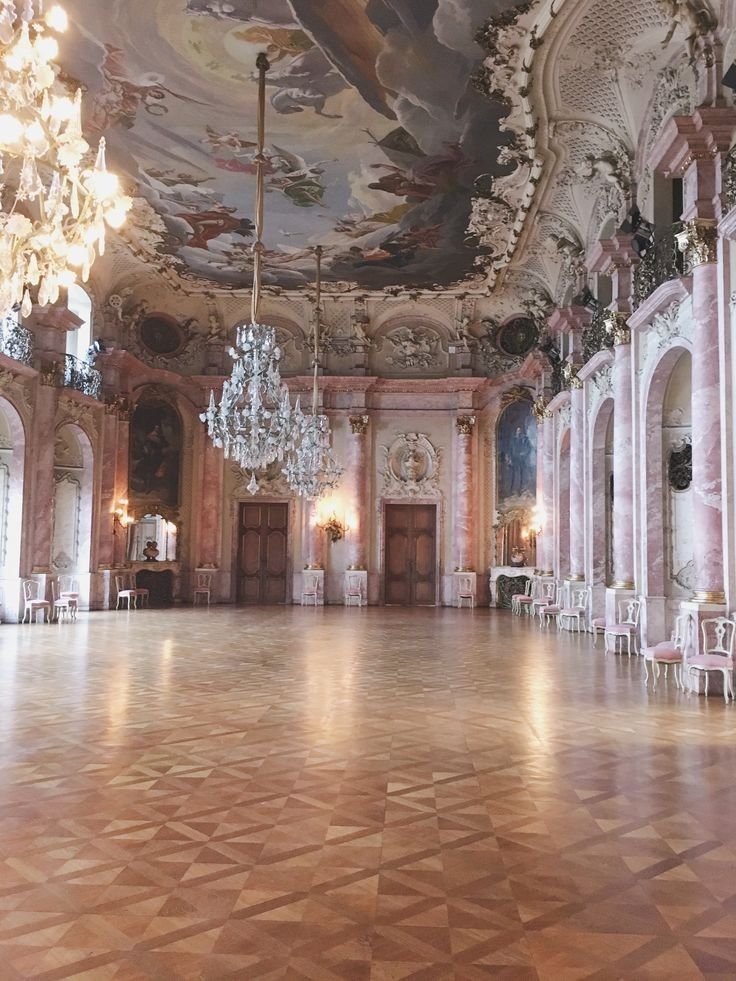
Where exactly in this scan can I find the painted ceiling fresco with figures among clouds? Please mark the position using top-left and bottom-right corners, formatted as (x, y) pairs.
(62, 0), (514, 289)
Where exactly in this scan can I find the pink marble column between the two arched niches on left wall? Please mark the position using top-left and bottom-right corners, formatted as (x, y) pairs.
(30, 375), (58, 573)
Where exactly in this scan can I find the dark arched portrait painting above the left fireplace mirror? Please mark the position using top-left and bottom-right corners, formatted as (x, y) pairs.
(130, 400), (181, 507)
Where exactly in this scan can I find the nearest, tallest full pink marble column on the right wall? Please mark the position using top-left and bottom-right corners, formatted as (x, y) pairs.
(687, 234), (725, 603)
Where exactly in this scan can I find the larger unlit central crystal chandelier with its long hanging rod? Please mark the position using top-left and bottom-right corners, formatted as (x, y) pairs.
(200, 52), (300, 494)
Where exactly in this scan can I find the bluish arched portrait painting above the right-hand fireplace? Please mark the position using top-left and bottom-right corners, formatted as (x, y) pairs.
(496, 401), (537, 508)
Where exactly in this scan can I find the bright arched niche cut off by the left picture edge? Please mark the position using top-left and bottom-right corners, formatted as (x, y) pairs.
(0, 396), (26, 621)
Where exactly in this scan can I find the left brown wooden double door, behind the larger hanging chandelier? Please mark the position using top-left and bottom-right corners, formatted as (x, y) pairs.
(237, 501), (289, 603)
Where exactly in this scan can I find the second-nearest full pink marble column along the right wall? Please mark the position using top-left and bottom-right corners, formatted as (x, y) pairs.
(611, 313), (634, 589)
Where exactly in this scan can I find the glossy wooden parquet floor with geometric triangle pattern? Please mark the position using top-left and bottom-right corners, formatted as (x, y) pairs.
(0, 608), (736, 981)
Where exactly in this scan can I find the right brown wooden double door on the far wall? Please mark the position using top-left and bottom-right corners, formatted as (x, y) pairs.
(384, 504), (437, 606)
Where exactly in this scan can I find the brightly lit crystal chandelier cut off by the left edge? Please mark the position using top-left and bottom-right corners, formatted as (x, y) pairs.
(0, 0), (132, 318)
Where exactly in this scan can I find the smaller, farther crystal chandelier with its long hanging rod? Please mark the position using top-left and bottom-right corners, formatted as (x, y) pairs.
(284, 246), (343, 498)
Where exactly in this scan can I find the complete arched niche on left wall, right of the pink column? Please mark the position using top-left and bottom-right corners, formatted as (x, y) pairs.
(51, 423), (94, 575)
